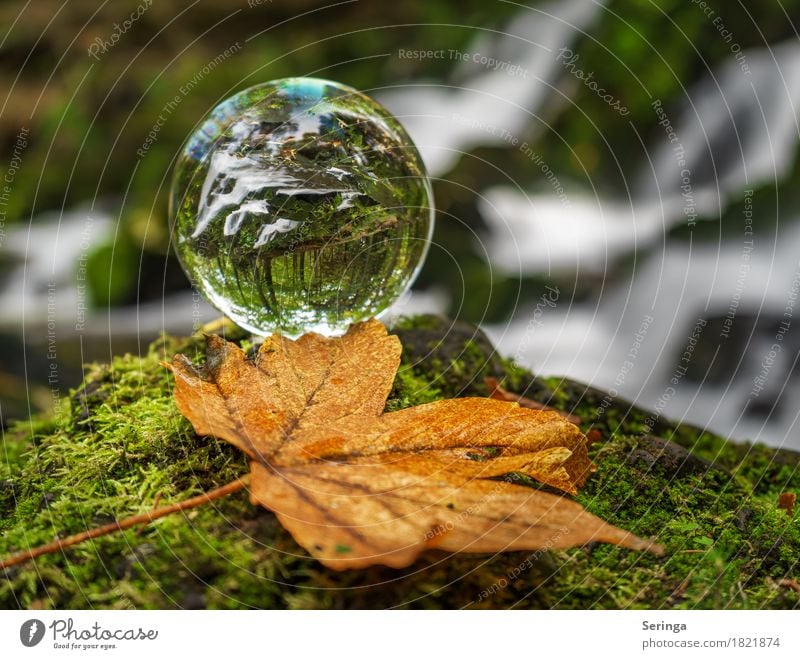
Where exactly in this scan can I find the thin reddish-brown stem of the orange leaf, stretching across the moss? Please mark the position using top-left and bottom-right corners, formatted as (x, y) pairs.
(0, 476), (249, 570)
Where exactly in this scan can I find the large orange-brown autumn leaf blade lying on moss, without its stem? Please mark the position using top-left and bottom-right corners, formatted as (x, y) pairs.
(164, 320), (661, 570)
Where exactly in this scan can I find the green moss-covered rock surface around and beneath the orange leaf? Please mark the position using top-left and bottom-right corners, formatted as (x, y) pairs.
(0, 317), (800, 608)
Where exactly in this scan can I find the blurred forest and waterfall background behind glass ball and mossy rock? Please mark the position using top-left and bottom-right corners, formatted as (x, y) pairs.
(0, 0), (800, 447)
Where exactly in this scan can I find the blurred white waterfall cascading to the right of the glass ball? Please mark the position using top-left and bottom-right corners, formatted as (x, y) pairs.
(381, 0), (800, 448)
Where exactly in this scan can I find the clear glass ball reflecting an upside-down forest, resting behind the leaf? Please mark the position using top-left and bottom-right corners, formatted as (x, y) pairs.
(170, 78), (433, 337)
